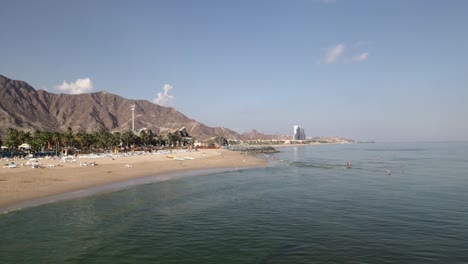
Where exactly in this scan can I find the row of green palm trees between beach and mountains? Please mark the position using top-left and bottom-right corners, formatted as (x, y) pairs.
(0, 126), (193, 153)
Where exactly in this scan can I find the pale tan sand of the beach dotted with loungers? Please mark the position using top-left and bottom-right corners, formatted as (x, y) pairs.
(0, 149), (266, 209)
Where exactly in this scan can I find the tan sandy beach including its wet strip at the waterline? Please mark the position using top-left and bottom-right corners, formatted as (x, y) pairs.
(0, 149), (267, 213)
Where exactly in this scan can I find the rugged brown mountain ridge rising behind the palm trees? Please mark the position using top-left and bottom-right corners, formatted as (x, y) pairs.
(0, 75), (240, 139)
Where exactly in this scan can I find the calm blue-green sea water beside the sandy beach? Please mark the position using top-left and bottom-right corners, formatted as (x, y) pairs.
(0, 142), (468, 263)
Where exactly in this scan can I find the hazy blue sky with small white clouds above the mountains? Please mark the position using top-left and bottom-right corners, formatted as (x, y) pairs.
(0, 0), (468, 142)
